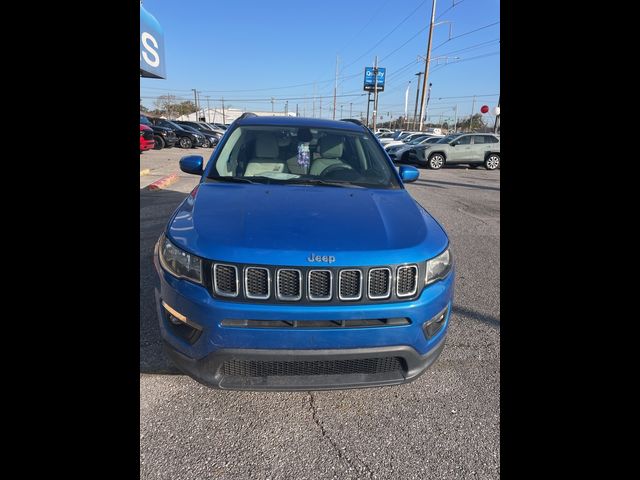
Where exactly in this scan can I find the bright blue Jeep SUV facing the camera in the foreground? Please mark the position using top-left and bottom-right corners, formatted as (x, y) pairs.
(154, 114), (454, 390)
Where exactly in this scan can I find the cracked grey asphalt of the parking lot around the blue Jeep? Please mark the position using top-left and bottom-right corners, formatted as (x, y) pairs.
(140, 148), (500, 480)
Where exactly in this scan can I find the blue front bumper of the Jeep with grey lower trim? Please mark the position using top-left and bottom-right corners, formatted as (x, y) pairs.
(154, 252), (454, 390)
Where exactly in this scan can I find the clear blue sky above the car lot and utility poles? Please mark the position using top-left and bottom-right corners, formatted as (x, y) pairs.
(140, 0), (500, 123)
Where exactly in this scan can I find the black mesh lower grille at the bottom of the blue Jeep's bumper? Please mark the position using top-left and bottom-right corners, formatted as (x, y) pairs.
(222, 357), (403, 377)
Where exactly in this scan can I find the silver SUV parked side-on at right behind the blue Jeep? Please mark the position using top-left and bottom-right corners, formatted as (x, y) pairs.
(413, 133), (500, 170)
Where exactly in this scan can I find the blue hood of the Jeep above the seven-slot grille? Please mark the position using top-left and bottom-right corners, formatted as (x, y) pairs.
(166, 183), (448, 266)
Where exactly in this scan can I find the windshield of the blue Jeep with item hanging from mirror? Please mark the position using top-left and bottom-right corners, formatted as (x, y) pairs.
(209, 126), (401, 189)
